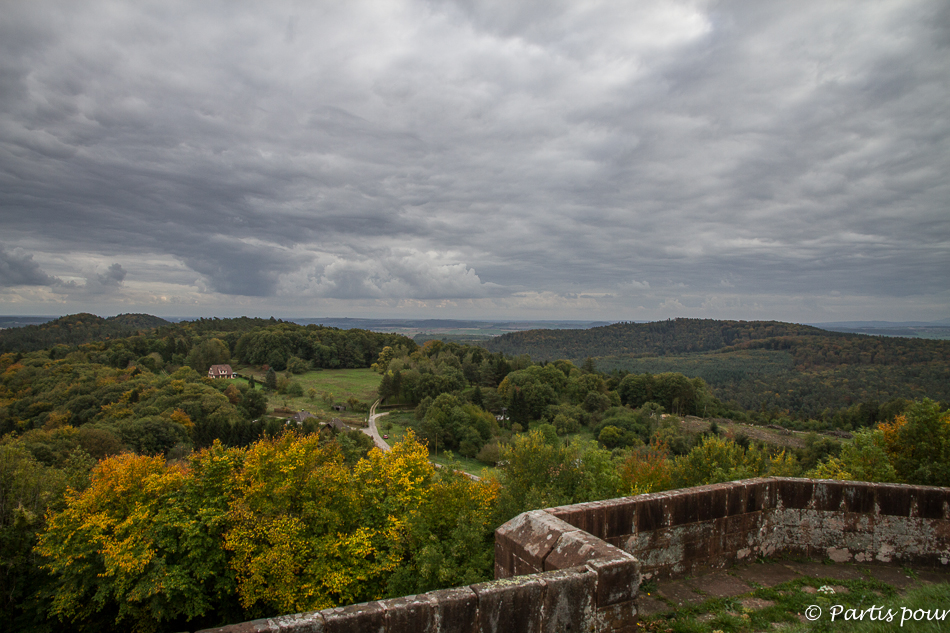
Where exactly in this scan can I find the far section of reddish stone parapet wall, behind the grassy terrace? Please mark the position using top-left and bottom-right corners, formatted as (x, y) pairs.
(544, 478), (950, 578)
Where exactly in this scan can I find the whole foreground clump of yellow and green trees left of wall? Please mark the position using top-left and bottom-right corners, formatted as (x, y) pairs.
(36, 432), (497, 631)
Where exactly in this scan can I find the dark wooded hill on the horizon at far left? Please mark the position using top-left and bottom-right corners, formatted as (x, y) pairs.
(0, 313), (169, 353)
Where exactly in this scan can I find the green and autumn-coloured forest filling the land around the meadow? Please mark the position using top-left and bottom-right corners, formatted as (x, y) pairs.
(0, 315), (950, 631)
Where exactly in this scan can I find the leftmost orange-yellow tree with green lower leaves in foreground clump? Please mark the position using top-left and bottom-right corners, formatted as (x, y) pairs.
(36, 443), (240, 631)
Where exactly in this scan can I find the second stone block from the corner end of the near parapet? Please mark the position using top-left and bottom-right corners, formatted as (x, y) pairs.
(471, 576), (544, 633)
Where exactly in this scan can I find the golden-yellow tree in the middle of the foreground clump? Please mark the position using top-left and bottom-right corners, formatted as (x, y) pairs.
(225, 433), (359, 613)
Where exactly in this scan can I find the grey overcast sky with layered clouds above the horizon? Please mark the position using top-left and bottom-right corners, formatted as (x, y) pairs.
(0, 0), (950, 322)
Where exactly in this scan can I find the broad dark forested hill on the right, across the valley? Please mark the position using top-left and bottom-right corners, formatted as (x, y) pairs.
(486, 319), (950, 426)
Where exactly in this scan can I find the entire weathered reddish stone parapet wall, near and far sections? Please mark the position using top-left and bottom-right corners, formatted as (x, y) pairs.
(202, 478), (950, 633)
